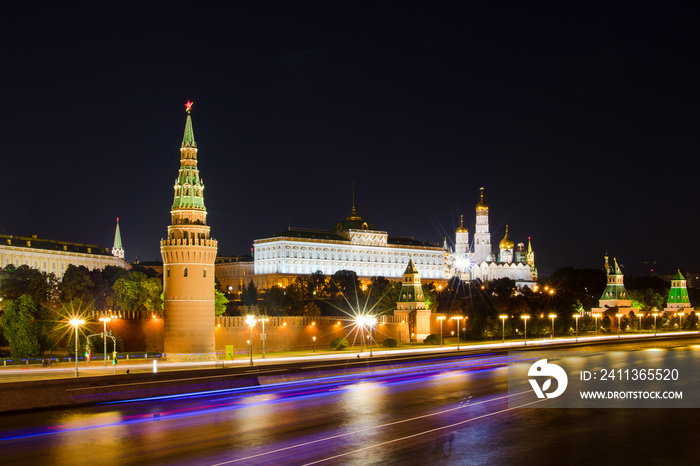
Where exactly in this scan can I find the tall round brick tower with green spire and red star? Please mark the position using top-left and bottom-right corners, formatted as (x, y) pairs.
(160, 101), (217, 360)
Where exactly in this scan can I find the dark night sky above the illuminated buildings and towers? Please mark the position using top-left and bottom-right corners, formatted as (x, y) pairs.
(0, 1), (700, 276)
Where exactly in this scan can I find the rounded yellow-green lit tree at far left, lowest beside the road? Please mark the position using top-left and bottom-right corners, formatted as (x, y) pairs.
(0, 294), (50, 358)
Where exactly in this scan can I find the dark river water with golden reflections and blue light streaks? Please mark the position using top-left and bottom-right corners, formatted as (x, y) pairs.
(0, 345), (700, 466)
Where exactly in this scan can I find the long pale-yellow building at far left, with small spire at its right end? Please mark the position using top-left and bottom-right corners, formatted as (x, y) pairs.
(0, 224), (130, 280)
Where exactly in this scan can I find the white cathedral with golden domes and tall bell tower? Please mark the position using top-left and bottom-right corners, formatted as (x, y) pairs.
(444, 188), (537, 288)
